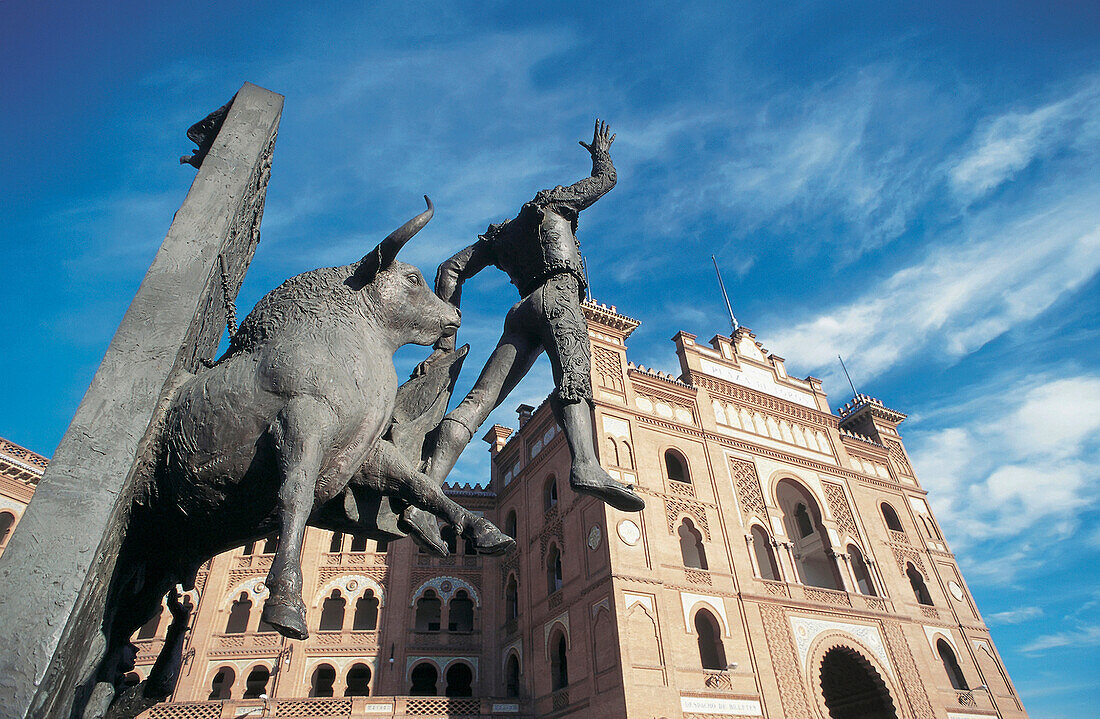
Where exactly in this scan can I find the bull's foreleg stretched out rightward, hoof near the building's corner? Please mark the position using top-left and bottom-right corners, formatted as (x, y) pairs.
(375, 442), (516, 554)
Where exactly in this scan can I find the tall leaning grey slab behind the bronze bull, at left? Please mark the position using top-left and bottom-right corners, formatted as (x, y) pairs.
(0, 84), (283, 719)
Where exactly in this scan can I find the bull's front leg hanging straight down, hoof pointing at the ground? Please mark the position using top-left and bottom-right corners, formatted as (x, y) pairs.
(262, 396), (337, 639)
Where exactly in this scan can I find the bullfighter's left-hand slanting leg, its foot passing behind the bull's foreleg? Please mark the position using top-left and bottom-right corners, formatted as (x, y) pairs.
(402, 299), (542, 556)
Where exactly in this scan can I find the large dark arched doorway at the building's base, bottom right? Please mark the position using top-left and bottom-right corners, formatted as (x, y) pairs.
(821, 646), (898, 719)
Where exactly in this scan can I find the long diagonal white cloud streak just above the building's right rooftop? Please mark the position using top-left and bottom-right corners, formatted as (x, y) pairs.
(769, 186), (1100, 389)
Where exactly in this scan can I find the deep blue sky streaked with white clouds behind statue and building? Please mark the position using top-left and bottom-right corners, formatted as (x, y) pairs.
(0, 1), (1100, 718)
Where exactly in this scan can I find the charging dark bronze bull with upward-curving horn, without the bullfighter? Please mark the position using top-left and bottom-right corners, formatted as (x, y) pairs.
(85, 197), (515, 717)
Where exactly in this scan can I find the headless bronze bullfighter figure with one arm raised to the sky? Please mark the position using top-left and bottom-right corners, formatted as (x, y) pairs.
(404, 120), (645, 552)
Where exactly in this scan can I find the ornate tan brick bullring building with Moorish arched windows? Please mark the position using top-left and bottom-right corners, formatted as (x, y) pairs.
(4, 302), (1026, 719)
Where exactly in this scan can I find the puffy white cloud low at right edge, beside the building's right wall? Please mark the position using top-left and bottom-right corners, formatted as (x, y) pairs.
(909, 374), (1100, 580)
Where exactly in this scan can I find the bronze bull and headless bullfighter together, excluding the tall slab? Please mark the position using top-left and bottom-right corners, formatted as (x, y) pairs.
(85, 120), (645, 718)
